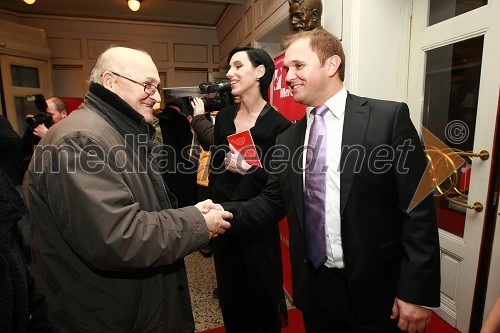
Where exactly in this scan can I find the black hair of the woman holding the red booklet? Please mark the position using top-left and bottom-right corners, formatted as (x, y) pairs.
(227, 46), (274, 101)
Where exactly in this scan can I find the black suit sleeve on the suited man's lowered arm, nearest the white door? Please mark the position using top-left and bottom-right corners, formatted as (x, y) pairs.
(392, 103), (440, 307)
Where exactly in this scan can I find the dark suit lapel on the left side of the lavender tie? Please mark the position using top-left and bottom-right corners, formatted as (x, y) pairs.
(289, 117), (307, 232)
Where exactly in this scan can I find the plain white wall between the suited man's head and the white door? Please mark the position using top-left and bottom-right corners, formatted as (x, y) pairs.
(344, 0), (411, 101)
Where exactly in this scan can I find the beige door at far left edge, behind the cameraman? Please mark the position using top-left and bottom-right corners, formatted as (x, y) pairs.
(0, 55), (52, 136)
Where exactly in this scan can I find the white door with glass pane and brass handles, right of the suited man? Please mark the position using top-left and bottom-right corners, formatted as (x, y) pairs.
(408, 0), (500, 332)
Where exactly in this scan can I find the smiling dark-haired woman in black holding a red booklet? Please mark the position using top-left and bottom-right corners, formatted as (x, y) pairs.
(192, 46), (290, 333)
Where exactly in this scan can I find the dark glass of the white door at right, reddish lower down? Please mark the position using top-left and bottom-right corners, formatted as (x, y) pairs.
(423, 36), (484, 237)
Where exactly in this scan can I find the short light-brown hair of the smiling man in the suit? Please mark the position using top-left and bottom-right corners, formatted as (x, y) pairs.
(283, 28), (345, 82)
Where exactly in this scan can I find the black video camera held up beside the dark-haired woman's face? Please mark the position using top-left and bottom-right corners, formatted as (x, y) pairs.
(180, 80), (234, 114)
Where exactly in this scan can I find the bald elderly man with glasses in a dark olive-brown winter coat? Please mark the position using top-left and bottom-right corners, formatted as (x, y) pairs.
(29, 47), (231, 333)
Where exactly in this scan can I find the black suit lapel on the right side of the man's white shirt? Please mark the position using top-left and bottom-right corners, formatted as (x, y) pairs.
(340, 94), (370, 216)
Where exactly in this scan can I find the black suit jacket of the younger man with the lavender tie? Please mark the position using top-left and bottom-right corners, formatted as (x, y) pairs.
(223, 94), (440, 320)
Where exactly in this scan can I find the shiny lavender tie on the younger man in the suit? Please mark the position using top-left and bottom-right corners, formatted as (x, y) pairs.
(304, 105), (328, 268)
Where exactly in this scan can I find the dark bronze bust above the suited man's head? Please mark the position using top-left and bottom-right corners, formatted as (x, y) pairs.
(288, 0), (323, 33)
